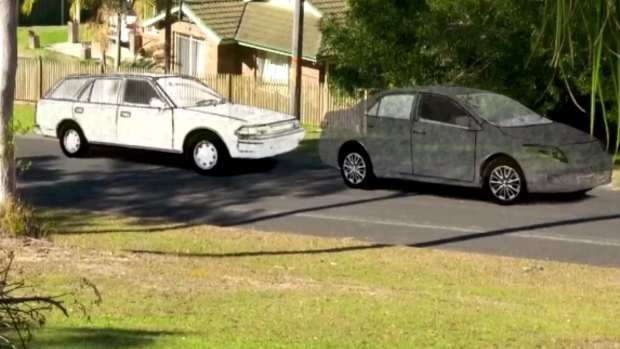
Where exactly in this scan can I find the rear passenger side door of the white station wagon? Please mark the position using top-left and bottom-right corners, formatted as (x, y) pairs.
(72, 77), (122, 143)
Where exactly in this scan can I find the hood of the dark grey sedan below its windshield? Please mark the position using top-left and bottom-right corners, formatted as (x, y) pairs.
(500, 122), (596, 145)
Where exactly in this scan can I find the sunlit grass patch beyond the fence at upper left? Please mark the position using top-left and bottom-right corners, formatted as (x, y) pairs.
(17, 26), (80, 62)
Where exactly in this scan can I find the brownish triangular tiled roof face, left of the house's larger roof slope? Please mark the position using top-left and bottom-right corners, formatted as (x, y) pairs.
(188, 0), (245, 40)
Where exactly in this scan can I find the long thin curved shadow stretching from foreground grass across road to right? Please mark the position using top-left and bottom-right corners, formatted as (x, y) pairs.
(126, 213), (620, 258)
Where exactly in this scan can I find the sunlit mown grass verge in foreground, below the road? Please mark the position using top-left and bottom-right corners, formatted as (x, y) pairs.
(4, 207), (620, 349)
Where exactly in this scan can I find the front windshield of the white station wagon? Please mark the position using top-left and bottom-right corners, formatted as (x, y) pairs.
(157, 76), (225, 108)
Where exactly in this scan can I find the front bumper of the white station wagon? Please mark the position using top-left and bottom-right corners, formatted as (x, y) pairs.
(236, 129), (306, 159)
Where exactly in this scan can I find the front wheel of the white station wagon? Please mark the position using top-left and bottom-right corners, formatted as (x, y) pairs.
(185, 132), (230, 176)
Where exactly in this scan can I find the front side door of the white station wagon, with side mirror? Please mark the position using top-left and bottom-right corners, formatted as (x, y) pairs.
(117, 78), (172, 150)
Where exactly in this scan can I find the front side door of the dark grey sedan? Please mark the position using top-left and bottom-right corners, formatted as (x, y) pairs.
(411, 93), (477, 181)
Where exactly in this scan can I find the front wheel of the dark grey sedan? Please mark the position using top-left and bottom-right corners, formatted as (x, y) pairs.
(484, 157), (527, 205)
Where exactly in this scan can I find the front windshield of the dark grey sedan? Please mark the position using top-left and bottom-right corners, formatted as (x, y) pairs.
(457, 93), (551, 127)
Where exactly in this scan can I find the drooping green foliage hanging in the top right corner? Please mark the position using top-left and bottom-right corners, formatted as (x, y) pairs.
(541, 0), (620, 158)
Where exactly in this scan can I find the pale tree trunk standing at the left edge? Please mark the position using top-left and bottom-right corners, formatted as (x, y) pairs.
(0, 0), (18, 205)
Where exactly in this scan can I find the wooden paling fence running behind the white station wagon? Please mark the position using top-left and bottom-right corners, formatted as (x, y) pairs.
(15, 57), (358, 126)
